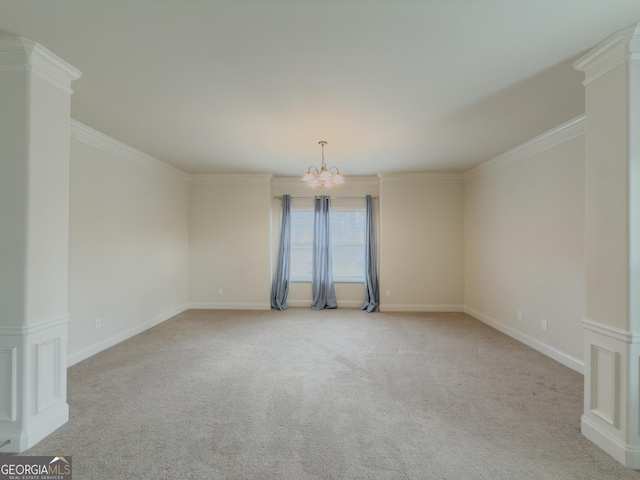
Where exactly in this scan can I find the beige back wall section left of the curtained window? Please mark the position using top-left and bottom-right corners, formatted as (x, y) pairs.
(188, 175), (271, 309)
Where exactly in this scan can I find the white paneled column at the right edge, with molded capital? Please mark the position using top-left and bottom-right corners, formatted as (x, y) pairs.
(574, 24), (640, 469)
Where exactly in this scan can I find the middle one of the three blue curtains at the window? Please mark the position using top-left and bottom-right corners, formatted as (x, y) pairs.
(311, 195), (338, 310)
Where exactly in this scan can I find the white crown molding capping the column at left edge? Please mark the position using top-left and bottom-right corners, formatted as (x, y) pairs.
(0, 35), (82, 94)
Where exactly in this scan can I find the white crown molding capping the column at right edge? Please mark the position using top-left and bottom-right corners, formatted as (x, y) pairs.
(573, 23), (640, 86)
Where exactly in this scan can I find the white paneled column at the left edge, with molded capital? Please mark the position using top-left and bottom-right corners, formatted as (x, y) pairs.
(0, 36), (80, 453)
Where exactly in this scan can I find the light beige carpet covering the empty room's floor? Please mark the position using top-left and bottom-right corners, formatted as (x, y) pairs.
(16, 309), (640, 480)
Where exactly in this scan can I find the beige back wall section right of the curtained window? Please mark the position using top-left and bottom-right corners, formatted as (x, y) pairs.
(380, 175), (464, 311)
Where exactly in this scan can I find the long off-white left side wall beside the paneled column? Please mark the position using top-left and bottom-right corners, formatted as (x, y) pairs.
(69, 132), (189, 364)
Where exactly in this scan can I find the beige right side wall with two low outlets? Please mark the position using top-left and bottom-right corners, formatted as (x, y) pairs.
(465, 135), (585, 359)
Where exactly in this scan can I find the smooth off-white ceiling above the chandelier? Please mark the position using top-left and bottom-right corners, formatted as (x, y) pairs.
(0, 0), (640, 177)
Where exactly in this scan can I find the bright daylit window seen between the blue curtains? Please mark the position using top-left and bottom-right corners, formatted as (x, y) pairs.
(290, 202), (366, 282)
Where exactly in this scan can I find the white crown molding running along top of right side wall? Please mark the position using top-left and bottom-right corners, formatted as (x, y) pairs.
(463, 115), (585, 182)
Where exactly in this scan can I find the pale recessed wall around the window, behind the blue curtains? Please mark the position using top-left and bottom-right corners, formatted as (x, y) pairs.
(271, 177), (380, 308)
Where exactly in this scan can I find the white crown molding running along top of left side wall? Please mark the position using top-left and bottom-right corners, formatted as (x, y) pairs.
(71, 119), (191, 181)
